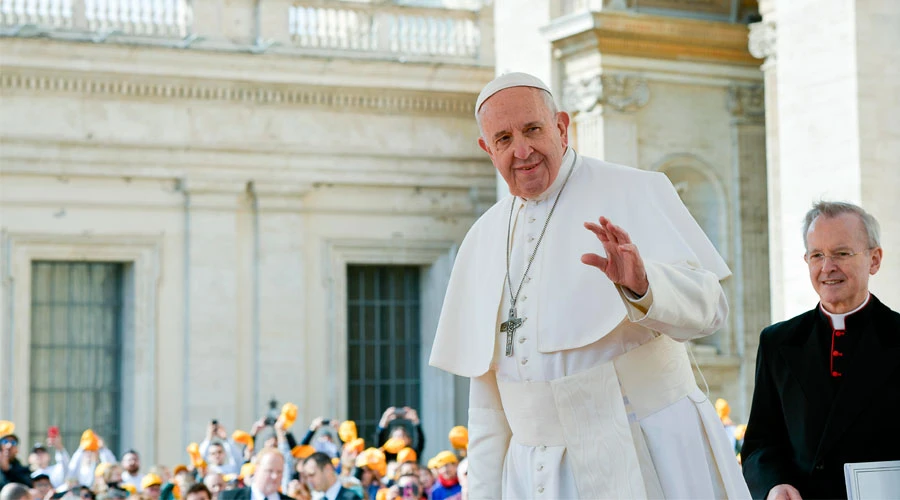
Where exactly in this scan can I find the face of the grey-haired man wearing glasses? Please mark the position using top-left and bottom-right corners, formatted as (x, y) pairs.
(806, 214), (882, 314)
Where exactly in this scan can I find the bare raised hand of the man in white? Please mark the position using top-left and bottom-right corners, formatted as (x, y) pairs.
(581, 217), (650, 296)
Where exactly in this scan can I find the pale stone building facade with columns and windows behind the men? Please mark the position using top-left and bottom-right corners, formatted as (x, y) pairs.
(0, 0), (900, 463)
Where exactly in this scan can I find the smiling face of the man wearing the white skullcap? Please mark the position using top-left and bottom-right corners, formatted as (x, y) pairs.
(478, 87), (569, 198)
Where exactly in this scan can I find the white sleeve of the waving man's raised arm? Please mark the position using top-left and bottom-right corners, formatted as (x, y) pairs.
(616, 260), (728, 342)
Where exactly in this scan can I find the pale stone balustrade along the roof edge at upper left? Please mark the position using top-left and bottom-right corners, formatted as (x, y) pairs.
(0, 0), (493, 65)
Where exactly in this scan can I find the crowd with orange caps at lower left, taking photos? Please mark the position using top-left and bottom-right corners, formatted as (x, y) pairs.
(0, 403), (468, 500)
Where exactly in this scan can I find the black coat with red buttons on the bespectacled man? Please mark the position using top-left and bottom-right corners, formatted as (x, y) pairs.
(741, 295), (900, 500)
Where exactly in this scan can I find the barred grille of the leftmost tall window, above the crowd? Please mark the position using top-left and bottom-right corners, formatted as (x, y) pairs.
(28, 261), (124, 453)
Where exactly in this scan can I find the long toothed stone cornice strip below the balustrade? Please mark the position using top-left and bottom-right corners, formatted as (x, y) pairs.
(0, 71), (475, 117)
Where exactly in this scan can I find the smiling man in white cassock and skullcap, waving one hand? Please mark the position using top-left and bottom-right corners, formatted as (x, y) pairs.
(431, 73), (750, 500)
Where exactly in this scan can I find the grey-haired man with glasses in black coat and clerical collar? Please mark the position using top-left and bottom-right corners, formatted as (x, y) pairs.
(741, 202), (900, 500)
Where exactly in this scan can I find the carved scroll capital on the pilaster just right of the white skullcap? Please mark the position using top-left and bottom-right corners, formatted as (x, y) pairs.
(563, 75), (650, 113)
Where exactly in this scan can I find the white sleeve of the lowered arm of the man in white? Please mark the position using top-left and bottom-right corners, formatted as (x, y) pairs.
(468, 370), (512, 500)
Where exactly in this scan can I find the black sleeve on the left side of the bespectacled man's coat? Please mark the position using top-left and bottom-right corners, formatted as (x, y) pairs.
(741, 330), (799, 498)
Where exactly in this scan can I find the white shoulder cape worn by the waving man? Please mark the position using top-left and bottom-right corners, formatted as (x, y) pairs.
(430, 155), (731, 377)
